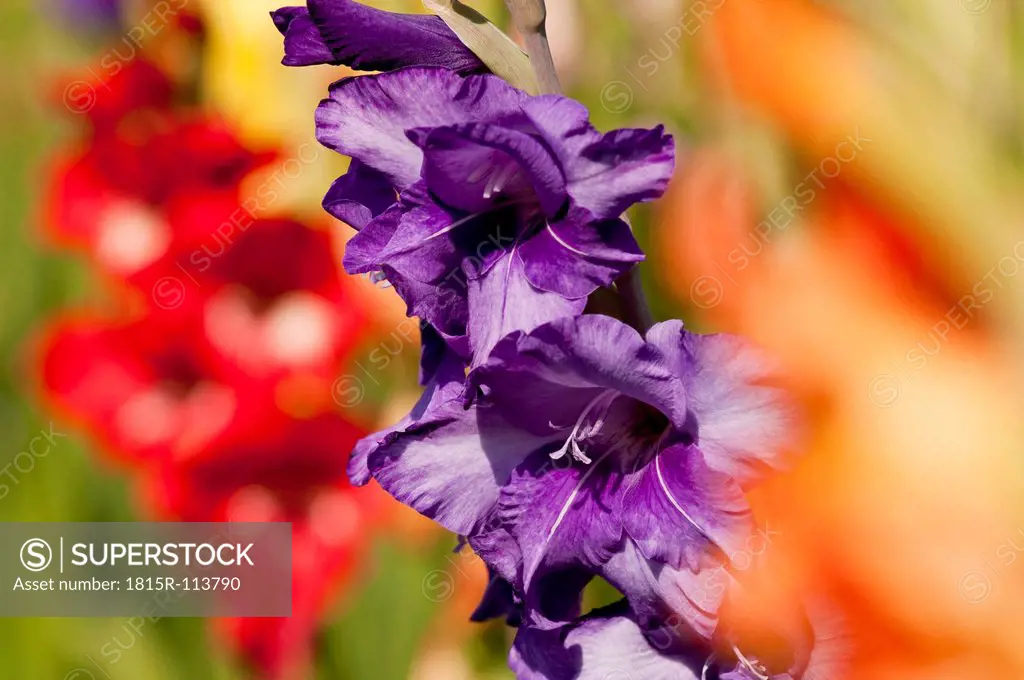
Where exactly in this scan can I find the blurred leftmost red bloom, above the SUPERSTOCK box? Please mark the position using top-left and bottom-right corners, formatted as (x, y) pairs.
(41, 307), (272, 462)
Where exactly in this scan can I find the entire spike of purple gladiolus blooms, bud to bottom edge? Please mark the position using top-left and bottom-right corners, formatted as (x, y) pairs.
(271, 0), (842, 680)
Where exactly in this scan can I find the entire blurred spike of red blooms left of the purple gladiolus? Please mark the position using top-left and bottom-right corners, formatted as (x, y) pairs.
(41, 43), (386, 678)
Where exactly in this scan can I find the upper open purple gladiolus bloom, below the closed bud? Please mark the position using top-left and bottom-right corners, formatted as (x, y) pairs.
(316, 68), (675, 364)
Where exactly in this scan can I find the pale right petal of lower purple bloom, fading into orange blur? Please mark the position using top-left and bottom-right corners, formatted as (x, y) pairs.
(647, 322), (798, 488)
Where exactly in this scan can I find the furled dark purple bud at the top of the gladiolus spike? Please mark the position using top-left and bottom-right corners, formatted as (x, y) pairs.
(270, 0), (486, 74)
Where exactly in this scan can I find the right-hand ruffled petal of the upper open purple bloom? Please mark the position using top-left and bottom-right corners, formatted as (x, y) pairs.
(523, 95), (676, 219)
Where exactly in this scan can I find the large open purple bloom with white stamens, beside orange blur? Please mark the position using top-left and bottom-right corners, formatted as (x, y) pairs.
(364, 315), (790, 637)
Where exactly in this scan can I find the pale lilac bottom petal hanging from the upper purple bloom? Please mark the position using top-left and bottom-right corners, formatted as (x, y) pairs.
(469, 246), (587, 366)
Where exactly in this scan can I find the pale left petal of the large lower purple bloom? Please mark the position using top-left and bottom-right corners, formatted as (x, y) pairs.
(369, 397), (551, 536)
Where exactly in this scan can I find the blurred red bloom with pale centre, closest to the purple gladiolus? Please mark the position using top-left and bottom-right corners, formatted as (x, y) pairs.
(152, 219), (366, 387)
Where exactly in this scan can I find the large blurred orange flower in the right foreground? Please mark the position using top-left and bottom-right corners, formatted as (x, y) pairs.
(655, 0), (1024, 680)
